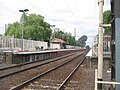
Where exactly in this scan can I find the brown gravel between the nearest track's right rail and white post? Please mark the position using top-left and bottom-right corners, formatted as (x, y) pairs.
(63, 59), (94, 90)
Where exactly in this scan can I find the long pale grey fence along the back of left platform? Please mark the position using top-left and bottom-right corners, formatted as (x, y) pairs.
(0, 36), (47, 51)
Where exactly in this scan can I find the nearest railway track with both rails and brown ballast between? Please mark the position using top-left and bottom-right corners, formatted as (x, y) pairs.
(11, 52), (87, 90)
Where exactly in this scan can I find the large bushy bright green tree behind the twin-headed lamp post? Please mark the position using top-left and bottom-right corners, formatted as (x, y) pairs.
(5, 14), (52, 41)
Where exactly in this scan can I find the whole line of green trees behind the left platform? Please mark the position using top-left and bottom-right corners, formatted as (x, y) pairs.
(5, 14), (88, 47)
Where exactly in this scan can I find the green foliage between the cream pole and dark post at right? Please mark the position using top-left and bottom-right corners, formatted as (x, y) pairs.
(103, 10), (111, 35)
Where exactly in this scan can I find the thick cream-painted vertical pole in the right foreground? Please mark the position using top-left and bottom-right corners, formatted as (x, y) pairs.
(98, 0), (104, 90)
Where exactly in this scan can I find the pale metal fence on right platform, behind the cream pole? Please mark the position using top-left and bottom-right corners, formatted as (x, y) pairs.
(92, 36), (111, 56)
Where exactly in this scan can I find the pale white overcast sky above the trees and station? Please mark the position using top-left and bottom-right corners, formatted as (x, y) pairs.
(0, 0), (110, 45)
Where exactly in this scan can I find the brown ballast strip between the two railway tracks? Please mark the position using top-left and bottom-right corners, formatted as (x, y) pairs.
(0, 50), (86, 90)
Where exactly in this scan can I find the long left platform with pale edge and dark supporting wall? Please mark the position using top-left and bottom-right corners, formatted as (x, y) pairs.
(0, 49), (85, 64)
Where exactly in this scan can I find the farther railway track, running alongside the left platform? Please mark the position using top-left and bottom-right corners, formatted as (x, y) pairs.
(0, 53), (79, 79)
